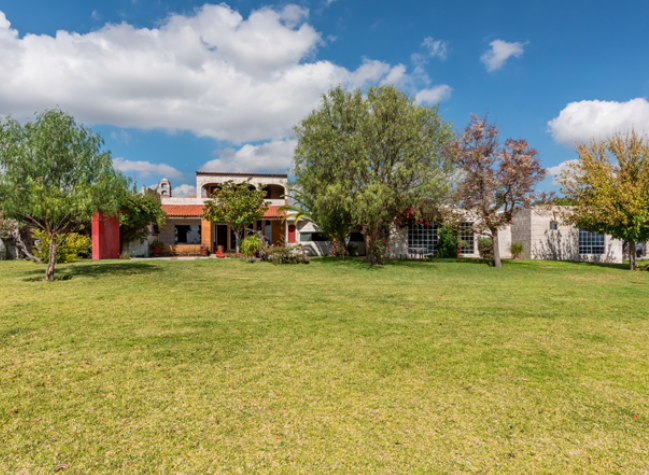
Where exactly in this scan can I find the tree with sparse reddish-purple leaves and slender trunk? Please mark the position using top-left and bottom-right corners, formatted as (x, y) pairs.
(450, 114), (548, 267)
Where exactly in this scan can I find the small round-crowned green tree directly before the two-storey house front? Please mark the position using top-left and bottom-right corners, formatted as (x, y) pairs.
(203, 179), (268, 252)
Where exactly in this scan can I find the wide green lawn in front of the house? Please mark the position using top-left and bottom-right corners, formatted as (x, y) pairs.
(0, 259), (649, 474)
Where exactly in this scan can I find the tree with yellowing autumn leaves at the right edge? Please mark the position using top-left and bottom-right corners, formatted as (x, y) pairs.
(557, 131), (649, 270)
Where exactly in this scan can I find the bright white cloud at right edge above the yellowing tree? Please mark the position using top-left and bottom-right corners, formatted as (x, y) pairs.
(548, 97), (649, 146)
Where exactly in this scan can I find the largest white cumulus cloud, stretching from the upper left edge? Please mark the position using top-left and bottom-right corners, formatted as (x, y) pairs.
(0, 4), (428, 144)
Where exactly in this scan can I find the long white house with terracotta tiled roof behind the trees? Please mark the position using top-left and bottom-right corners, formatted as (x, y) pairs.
(143, 171), (632, 263)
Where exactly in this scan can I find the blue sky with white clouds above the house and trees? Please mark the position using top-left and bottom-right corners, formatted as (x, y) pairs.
(0, 0), (649, 196)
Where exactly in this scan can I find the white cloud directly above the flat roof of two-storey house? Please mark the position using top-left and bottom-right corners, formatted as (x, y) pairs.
(201, 139), (297, 173)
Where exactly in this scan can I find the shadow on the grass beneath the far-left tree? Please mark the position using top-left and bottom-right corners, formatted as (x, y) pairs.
(25, 262), (160, 282)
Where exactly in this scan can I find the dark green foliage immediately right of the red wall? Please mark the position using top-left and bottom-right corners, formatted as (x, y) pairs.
(119, 190), (167, 247)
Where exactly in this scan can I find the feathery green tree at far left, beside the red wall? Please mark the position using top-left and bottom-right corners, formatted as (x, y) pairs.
(0, 110), (127, 281)
